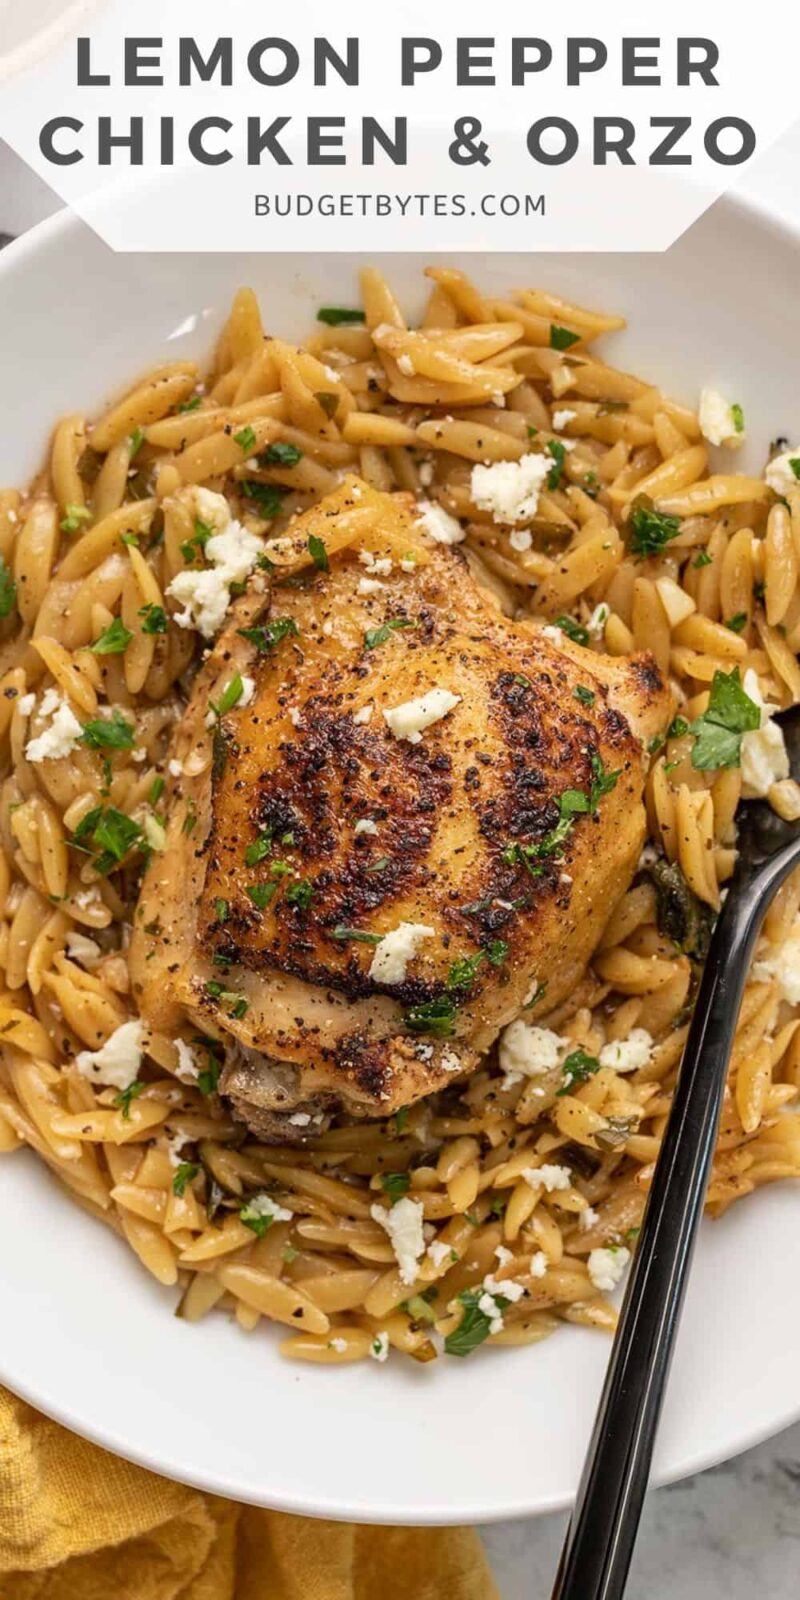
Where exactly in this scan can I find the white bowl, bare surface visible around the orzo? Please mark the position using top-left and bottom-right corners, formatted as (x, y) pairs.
(0, 202), (800, 1523)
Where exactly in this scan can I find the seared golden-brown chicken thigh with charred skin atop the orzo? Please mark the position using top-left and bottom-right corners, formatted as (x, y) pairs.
(131, 478), (670, 1138)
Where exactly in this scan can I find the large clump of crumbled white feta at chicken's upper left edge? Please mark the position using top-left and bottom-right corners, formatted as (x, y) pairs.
(166, 488), (264, 638)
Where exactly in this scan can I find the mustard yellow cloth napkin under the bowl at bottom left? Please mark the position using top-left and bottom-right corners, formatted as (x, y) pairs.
(0, 1389), (498, 1600)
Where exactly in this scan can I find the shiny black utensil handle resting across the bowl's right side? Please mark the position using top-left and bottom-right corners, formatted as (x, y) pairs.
(552, 845), (797, 1600)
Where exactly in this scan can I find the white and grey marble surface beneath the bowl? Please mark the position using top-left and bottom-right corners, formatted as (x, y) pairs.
(0, 123), (800, 1600)
